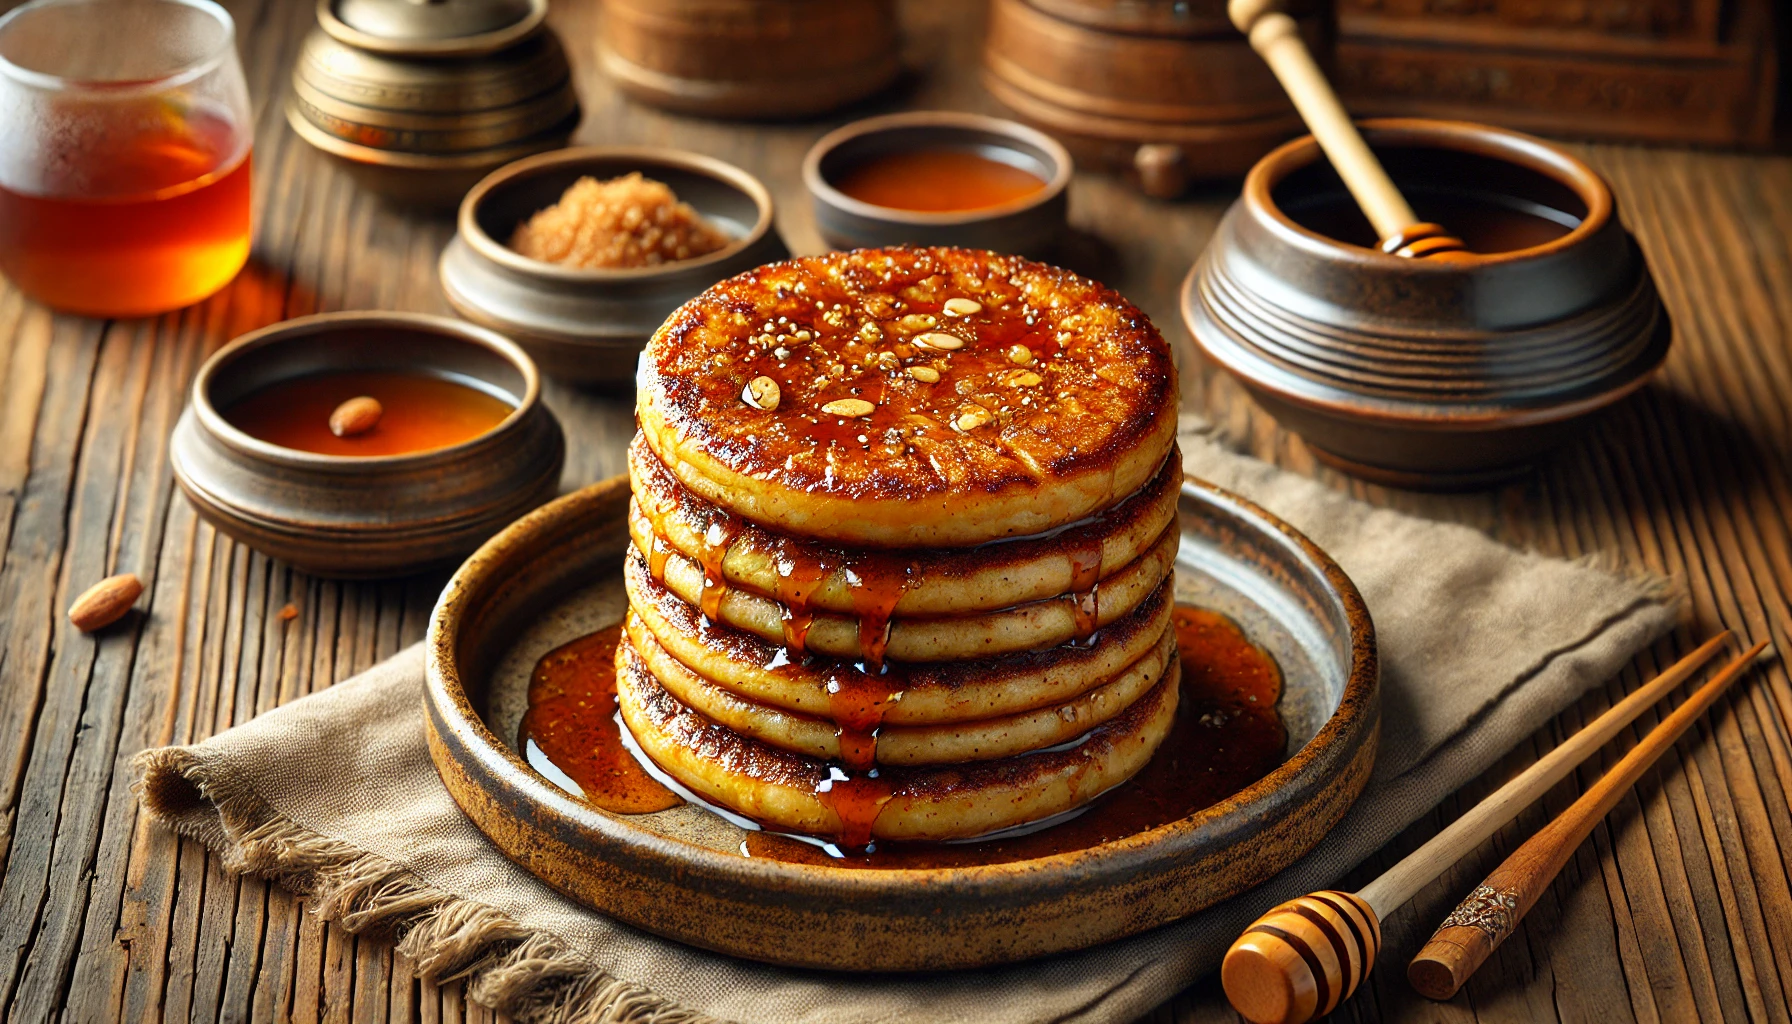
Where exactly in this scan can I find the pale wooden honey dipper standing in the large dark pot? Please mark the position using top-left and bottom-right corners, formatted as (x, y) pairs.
(1226, 0), (1477, 262)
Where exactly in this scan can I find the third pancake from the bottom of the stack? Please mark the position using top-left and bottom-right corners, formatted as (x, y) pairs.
(624, 566), (1174, 726)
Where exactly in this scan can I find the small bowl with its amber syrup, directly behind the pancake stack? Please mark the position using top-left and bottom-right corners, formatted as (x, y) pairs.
(803, 111), (1073, 256)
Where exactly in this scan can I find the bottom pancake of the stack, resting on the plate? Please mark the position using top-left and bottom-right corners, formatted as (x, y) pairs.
(616, 644), (1179, 846)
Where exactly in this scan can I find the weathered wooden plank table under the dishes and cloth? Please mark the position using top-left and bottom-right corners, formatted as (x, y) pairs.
(0, 0), (1792, 1022)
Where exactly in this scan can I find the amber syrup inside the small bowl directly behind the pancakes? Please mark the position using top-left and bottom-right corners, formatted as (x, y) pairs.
(831, 149), (1045, 213)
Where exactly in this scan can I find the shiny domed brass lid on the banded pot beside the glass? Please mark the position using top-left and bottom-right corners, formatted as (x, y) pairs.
(317, 0), (548, 57)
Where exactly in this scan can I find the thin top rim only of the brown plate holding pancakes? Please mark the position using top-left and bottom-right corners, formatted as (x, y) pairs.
(425, 473), (1380, 897)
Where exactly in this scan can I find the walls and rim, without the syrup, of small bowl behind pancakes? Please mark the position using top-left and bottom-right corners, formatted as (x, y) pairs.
(803, 111), (1073, 256)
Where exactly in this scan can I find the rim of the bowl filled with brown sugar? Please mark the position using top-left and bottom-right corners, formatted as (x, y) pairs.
(455, 145), (776, 283)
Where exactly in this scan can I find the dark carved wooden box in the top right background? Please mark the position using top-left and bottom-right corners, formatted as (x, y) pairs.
(1335, 0), (1787, 145)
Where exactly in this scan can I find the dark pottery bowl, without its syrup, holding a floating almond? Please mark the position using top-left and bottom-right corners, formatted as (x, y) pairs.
(172, 312), (566, 577)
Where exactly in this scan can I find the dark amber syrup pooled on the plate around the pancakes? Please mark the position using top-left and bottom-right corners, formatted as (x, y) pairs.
(521, 604), (1287, 868)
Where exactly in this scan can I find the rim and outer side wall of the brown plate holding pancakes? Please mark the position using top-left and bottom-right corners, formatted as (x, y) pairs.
(423, 477), (1380, 970)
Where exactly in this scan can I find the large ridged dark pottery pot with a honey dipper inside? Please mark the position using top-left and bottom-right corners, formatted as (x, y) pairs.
(1183, 120), (1672, 488)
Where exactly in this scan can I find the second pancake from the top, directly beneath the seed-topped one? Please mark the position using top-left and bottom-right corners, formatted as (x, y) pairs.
(629, 434), (1183, 616)
